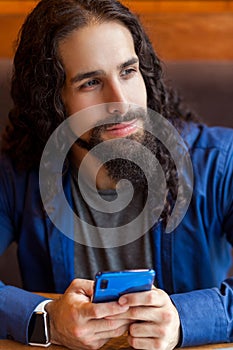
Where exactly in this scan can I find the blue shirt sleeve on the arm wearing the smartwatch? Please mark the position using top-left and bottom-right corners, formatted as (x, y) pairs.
(0, 158), (45, 343)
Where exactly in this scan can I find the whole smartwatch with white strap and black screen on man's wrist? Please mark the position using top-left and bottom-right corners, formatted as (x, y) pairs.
(28, 300), (51, 347)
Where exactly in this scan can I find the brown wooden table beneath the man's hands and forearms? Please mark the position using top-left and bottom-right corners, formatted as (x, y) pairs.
(0, 293), (233, 350)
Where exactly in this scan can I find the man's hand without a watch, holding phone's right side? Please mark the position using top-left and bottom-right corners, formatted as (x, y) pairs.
(107, 288), (180, 350)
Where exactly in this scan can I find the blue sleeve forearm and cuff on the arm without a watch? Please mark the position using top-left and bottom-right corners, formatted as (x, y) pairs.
(171, 283), (230, 347)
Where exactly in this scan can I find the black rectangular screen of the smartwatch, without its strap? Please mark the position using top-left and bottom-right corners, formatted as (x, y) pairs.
(29, 312), (49, 345)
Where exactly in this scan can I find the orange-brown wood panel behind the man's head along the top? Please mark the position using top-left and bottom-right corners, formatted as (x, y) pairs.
(0, 0), (233, 60)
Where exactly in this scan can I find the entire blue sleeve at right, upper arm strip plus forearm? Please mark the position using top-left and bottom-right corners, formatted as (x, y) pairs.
(171, 133), (233, 347)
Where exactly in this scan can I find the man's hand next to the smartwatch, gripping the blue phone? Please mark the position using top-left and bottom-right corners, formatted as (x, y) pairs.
(46, 279), (130, 349)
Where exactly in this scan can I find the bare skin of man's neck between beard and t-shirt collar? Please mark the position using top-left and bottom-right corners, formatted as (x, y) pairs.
(71, 144), (116, 190)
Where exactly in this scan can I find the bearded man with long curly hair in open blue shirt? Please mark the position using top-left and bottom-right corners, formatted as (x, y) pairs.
(0, 0), (233, 349)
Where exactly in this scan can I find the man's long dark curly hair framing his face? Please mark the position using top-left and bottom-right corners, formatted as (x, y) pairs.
(2, 0), (197, 224)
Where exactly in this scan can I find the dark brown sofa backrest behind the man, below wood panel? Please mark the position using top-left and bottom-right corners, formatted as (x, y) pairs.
(0, 59), (233, 286)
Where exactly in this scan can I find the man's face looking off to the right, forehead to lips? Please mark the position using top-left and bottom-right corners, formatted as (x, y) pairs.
(59, 22), (147, 142)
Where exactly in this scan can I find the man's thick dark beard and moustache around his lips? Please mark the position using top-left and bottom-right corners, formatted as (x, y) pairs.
(76, 108), (158, 190)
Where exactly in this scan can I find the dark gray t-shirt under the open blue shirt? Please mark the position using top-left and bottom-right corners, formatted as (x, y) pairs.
(71, 171), (154, 280)
